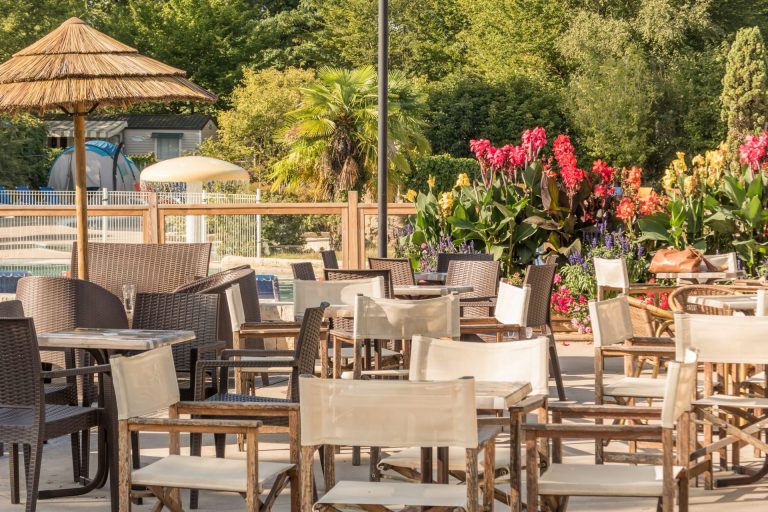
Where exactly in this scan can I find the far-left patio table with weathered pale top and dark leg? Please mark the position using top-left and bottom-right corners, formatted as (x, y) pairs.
(37, 328), (195, 512)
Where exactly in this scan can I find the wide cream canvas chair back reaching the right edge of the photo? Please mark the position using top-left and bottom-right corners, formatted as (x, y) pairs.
(675, 313), (768, 364)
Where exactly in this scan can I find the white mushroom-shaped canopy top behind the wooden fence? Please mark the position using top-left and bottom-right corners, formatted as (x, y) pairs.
(141, 156), (249, 183)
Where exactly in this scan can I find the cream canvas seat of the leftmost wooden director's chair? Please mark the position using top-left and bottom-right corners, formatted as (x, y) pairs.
(131, 455), (293, 493)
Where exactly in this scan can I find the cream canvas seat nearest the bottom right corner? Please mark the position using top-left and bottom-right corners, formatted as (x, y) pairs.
(539, 464), (684, 497)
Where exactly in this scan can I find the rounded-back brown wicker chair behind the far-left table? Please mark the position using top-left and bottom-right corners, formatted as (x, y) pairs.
(16, 276), (128, 481)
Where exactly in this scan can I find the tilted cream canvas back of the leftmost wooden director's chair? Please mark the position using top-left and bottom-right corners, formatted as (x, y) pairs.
(109, 347), (181, 420)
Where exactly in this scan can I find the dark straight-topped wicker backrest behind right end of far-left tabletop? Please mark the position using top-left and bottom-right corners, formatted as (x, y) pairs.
(133, 293), (219, 372)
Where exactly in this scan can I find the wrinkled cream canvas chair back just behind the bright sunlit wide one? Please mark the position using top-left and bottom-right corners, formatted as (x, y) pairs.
(353, 293), (461, 340)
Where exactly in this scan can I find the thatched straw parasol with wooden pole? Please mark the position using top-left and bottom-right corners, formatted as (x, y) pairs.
(0, 18), (216, 279)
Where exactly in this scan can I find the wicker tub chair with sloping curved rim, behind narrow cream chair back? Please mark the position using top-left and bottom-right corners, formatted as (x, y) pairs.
(173, 265), (261, 348)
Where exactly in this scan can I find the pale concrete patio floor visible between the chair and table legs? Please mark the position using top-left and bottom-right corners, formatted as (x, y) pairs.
(0, 343), (768, 512)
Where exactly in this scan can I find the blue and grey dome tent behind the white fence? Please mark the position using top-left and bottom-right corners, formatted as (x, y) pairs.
(48, 140), (140, 191)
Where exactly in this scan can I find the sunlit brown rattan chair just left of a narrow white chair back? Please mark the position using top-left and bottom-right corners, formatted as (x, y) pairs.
(445, 260), (501, 318)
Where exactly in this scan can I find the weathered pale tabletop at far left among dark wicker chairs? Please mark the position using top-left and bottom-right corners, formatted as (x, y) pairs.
(37, 328), (195, 351)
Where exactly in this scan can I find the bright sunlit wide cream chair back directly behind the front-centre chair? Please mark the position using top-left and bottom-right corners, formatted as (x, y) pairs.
(410, 336), (549, 395)
